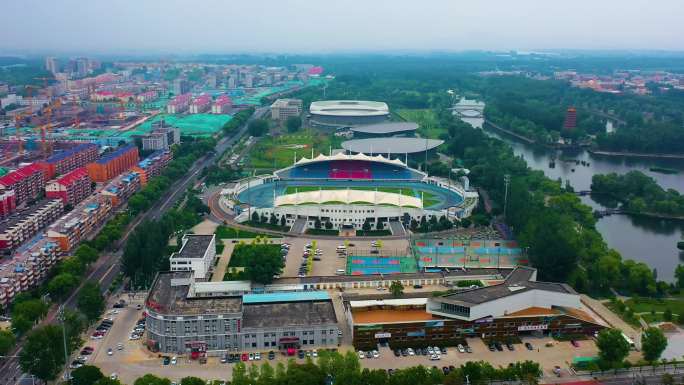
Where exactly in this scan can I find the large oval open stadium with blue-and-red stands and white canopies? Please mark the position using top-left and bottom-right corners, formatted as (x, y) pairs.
(221, 153), (478, 232)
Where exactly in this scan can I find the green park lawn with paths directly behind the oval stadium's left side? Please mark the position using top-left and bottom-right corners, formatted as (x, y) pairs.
(248, 129), (339, 169)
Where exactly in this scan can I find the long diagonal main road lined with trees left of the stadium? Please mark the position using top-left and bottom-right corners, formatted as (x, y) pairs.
(0, 107), (269, 385)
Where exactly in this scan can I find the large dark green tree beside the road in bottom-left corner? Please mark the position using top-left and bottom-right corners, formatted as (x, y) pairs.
(19, 325), (64, 381)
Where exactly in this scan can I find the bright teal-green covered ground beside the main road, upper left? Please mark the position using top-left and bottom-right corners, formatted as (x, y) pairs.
(137, 114), (233, 136)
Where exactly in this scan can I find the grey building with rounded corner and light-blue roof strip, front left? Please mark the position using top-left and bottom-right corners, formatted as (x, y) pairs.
(145, 271), (339, 357)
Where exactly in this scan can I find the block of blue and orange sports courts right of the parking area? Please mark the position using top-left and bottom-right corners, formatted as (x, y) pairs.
(412, 239), (528, 269)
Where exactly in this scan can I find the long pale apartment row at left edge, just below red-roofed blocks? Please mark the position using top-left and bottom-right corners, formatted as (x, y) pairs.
(0, 199), (64, 250)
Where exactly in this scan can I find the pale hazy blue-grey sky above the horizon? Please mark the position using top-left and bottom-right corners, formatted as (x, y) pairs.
(0, 0), (684, 54)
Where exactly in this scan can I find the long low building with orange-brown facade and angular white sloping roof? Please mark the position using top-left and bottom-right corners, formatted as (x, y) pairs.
(344, 267), (605, 349)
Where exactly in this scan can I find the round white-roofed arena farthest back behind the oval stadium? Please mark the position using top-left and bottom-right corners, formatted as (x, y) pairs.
(309, 100), (389, 128)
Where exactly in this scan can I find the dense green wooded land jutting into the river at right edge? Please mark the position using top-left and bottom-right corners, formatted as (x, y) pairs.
(591, 171), (684, 217)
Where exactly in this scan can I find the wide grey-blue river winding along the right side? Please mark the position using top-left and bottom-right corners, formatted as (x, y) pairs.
(469, 119), (684, 282)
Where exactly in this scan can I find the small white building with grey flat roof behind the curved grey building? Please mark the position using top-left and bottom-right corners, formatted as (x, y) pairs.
(169, 234), (216, 279)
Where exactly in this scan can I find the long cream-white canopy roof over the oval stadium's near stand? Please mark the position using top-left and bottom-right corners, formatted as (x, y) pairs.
(275, 189), (423, 208)
